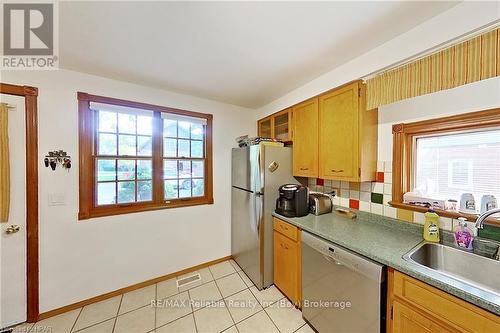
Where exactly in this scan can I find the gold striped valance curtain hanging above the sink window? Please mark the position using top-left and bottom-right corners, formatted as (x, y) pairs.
(366, 28), (500, 109)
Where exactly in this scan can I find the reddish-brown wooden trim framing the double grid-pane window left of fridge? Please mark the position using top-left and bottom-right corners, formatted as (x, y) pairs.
(77, 92), (214, 220)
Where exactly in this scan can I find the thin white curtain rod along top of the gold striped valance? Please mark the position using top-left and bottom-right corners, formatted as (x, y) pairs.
(361, 20), (500, 81)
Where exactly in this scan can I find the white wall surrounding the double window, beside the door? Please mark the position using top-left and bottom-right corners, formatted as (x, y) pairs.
(1, 70), (255, 312)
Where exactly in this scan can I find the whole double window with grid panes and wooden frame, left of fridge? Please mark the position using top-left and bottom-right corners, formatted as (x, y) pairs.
(78, 93), (213, 219)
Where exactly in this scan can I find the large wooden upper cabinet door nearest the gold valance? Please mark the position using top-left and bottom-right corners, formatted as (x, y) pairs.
(319, 82), (360, 181)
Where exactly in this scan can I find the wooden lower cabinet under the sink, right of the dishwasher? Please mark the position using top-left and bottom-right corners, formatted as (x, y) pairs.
(387, 270), (500, 333)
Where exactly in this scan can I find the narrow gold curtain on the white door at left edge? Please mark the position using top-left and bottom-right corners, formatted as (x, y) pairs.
(0, 103), (10, 222)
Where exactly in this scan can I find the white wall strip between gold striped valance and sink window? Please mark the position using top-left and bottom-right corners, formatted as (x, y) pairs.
(378, 77), (500, 161)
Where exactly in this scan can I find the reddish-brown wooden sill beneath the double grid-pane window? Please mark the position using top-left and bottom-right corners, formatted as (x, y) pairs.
(78, 197), (214, 220)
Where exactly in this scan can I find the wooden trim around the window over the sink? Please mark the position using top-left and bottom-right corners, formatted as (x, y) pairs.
(389, 108), (500, 226)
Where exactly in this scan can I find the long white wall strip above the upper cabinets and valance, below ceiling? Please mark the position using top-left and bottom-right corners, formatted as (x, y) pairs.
(256, 1), (500, 119)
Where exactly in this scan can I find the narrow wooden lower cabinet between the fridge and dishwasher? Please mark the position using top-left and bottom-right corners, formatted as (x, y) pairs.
(273, 218), (302, 307)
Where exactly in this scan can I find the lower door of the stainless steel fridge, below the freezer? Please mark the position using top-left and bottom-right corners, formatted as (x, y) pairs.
(231, 187), (264, 289)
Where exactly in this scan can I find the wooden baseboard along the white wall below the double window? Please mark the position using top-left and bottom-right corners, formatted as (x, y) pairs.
(38, 256), (231, 320)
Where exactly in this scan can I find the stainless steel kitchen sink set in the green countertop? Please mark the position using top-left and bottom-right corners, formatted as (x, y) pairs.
(403, 242), (500, 296)
